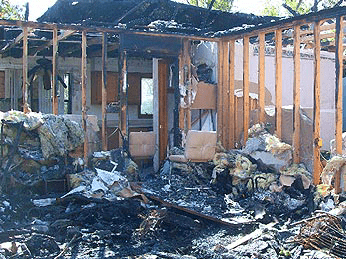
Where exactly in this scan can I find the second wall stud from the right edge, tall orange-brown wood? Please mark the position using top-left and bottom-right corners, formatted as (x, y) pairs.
(313, 21), (322, 185)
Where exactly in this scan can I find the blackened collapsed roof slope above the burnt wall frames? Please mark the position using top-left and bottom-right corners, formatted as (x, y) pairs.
(38, 0), (273, 36)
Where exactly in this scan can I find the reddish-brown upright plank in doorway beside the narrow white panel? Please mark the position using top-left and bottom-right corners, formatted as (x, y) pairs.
(158, 60), (168, 163)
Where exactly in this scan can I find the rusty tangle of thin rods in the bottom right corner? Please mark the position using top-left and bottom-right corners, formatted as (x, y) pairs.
(294, 212), (346, 258)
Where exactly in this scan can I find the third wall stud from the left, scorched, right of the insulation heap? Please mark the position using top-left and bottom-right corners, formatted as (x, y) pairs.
(82, 31), (89, 166)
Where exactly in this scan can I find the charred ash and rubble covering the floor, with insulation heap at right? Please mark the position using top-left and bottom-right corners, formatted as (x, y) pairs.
(0, 119), (346, 259)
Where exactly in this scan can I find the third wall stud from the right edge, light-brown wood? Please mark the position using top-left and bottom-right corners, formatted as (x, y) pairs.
(292, 25), (300, 163)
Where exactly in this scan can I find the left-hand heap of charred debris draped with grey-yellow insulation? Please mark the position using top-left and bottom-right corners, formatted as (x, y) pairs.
(0, 111), (84, 192)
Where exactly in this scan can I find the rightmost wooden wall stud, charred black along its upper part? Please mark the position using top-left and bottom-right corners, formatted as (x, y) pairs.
(334, 16), (343, 193)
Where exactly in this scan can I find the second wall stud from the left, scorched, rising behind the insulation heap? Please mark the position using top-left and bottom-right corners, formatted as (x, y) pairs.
(52, 28), (59, 115)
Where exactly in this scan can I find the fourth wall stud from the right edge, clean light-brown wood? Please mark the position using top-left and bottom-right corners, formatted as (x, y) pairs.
(275, 30), (282, 139)
